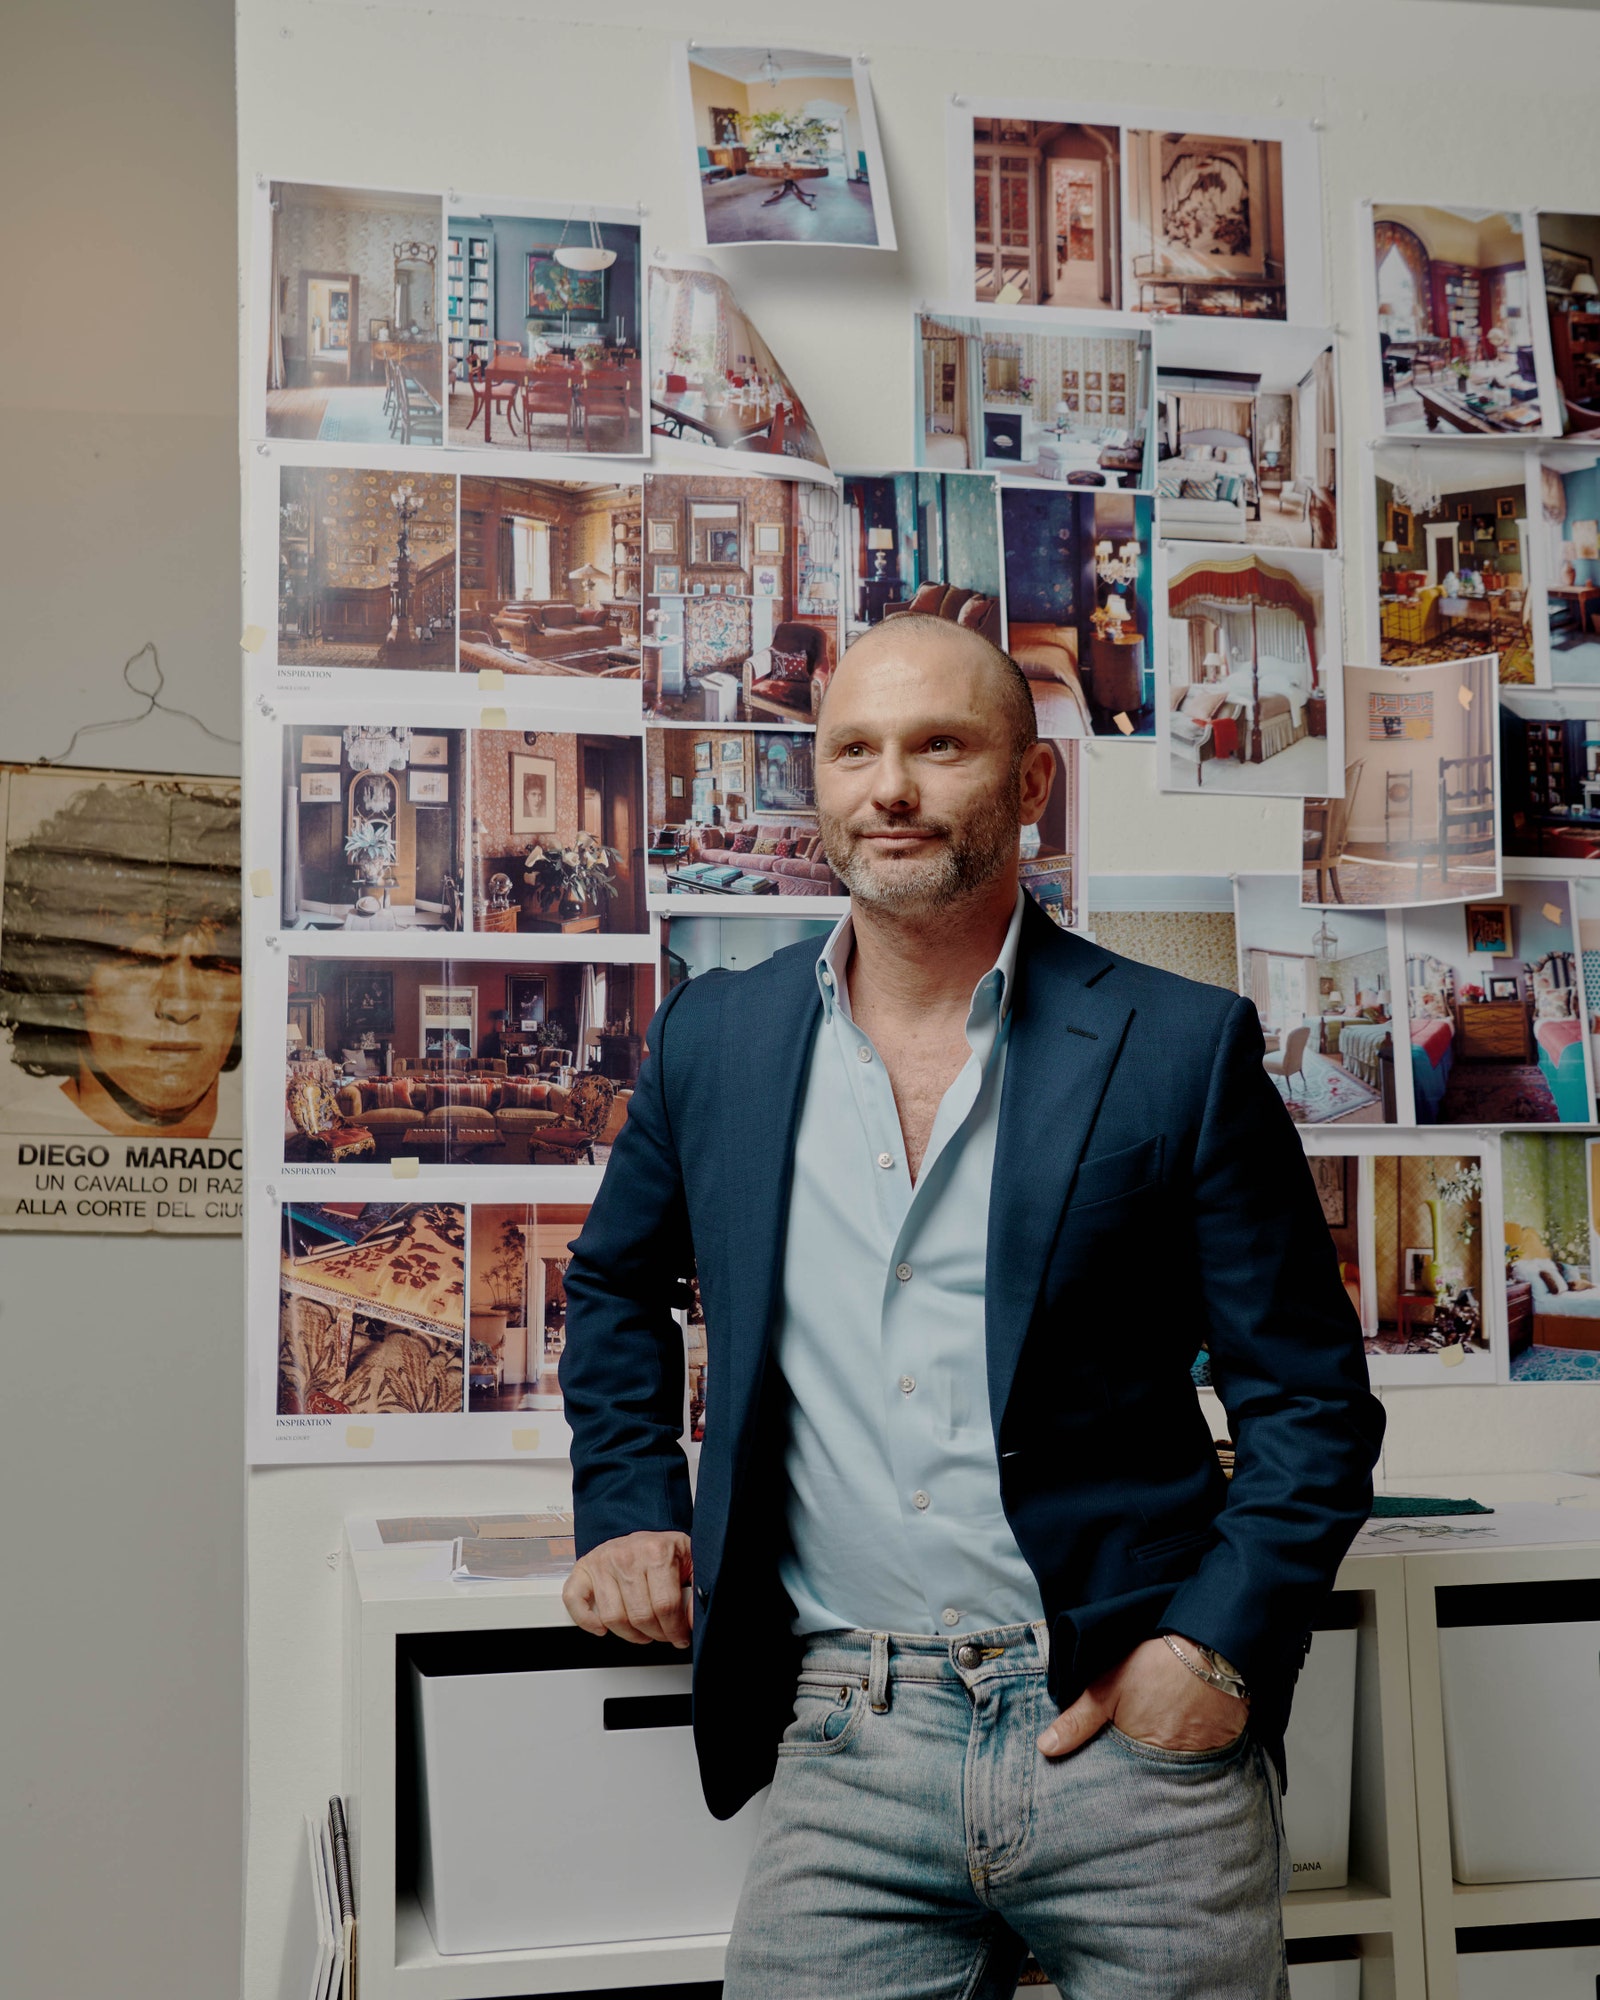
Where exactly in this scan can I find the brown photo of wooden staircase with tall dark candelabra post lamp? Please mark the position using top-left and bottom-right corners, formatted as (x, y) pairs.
(278, 466), (456, 674)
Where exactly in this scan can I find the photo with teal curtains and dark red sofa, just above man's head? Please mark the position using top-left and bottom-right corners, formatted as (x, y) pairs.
(840, 472), (1004, 646)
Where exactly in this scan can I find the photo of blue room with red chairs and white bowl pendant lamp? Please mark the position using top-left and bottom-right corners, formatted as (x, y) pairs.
(444, 202), (648, 458)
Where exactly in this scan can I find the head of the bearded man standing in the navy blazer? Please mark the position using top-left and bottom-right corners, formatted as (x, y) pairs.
(816, 622), (1052, 916)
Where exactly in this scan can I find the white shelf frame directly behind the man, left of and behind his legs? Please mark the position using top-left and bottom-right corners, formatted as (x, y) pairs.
(344, 1542), (1424, 2000)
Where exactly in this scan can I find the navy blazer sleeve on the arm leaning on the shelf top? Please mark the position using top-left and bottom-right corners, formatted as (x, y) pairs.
(560, 982), (694, 1556)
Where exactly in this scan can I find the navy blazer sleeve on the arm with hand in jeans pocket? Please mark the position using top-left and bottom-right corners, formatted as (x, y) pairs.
(1162, 1000), (1384, 1686)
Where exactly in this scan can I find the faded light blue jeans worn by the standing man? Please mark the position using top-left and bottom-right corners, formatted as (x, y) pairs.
(724, 1624), (1288, 2000)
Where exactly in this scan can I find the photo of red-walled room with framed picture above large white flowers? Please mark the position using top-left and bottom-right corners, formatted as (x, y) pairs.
(472, 730), (648, 938)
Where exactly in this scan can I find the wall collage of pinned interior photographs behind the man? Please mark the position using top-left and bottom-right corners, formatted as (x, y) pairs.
(244, 105), (1600, 1462)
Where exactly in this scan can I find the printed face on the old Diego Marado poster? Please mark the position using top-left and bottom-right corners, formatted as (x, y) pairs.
(84, 928), (240, 1118)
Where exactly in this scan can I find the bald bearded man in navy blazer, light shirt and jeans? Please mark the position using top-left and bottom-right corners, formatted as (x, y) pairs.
(562, 616), (1382, 2000)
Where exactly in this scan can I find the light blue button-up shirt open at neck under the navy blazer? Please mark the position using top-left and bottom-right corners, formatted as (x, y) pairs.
(776, 892), (1044, 1634)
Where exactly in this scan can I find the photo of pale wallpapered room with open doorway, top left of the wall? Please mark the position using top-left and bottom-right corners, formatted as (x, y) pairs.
(264, 180), (444, 444)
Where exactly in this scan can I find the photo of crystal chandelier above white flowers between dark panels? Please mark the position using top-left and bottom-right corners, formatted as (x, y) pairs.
(280, 722), (466, 930)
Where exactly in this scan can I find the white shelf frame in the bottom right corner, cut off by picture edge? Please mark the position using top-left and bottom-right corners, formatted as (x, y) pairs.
(1404, 1522), (1600, 2000)
